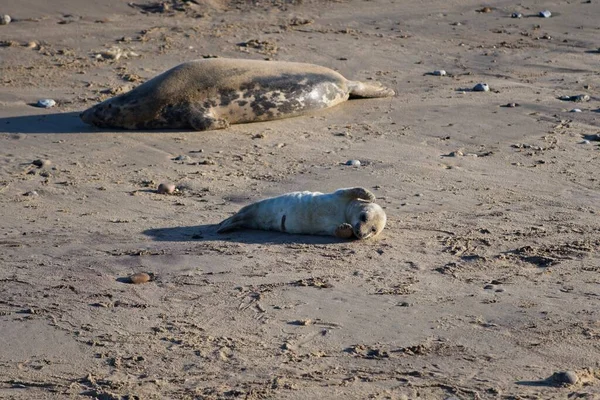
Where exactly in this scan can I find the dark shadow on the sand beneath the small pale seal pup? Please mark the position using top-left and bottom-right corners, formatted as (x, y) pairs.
(142, 225), (348, 244)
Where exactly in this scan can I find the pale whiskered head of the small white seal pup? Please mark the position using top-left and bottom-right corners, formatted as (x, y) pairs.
(346, 200), (387, 239)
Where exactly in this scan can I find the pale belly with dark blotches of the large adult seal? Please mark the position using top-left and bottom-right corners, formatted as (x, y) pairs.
(210, 75), (348, 124)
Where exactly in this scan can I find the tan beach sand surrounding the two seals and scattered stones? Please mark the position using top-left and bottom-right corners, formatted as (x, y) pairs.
(0, 0), (600, 399)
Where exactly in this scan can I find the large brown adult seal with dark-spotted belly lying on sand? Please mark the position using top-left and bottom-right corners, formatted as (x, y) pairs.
(80, 58), (394, 131)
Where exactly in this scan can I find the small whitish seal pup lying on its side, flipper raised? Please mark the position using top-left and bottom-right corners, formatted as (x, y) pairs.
(217, 187), (386, 239)
